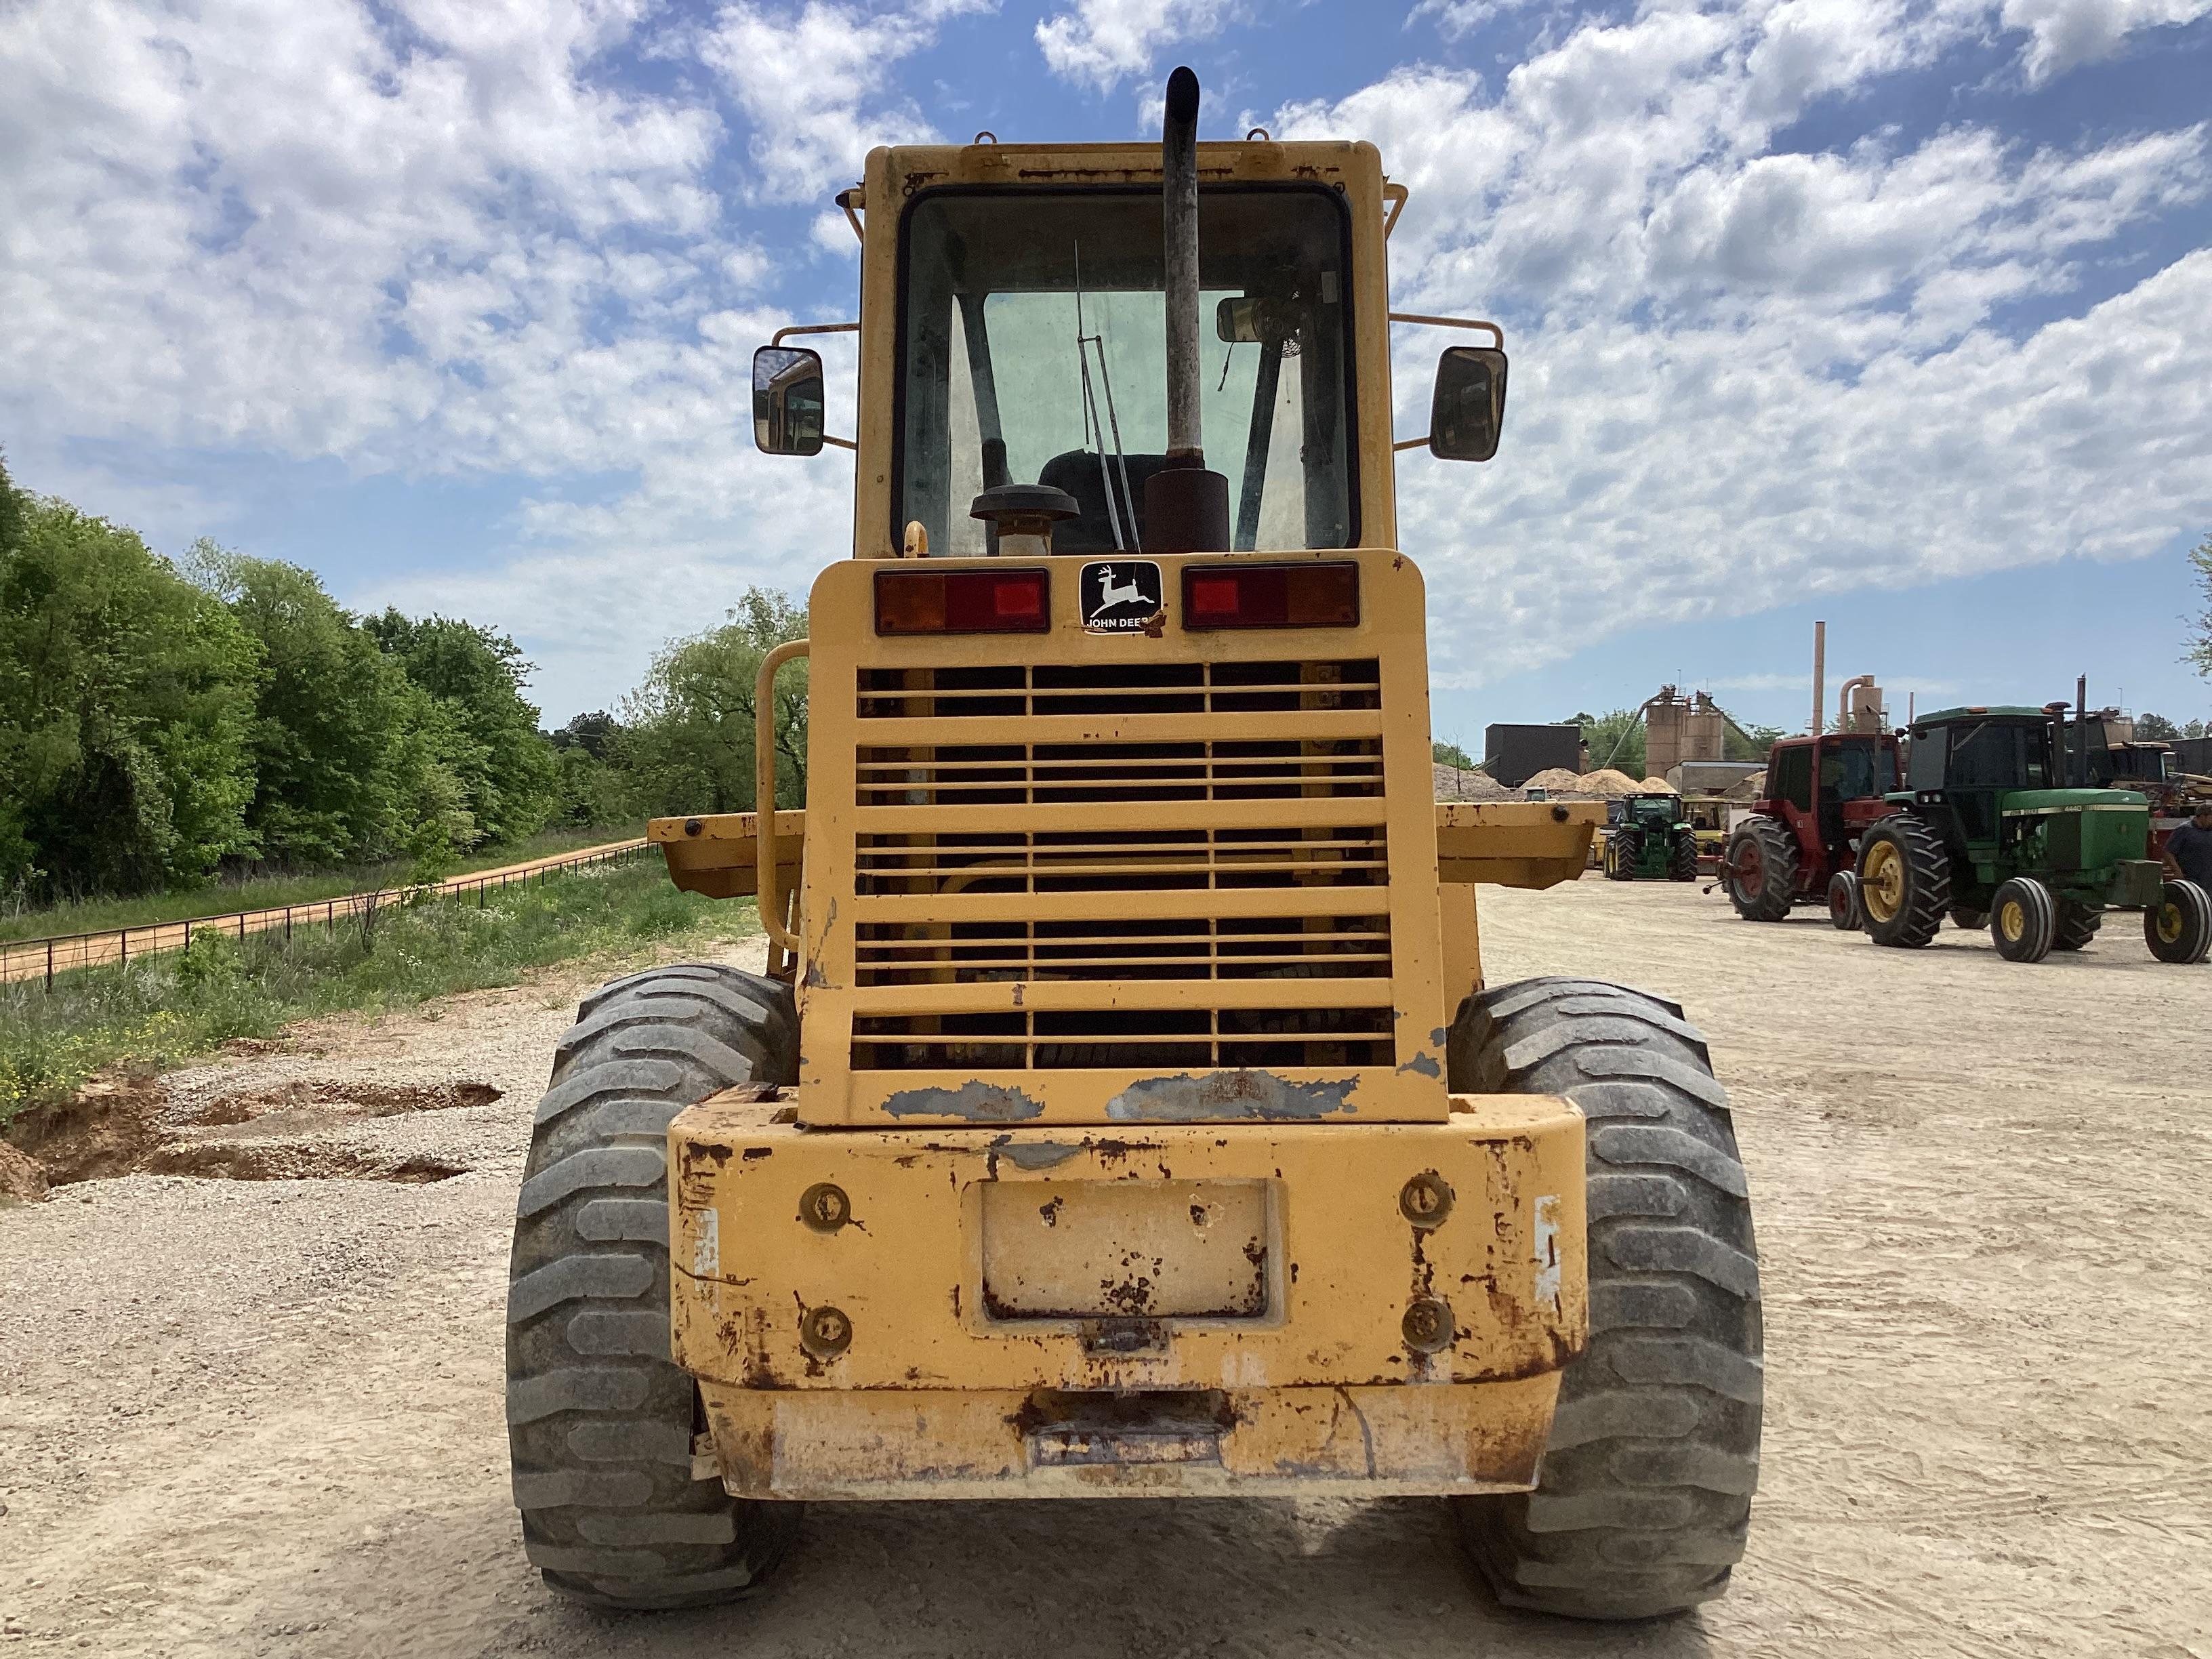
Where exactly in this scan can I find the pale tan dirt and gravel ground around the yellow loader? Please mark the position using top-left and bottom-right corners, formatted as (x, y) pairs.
(0, 878), (2212, 1659)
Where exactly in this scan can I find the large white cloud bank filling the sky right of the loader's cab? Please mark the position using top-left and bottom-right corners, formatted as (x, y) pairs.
(1270, 0), (2212, 686)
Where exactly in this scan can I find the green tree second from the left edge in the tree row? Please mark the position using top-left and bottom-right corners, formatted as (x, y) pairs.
(192, 542), (416, 865)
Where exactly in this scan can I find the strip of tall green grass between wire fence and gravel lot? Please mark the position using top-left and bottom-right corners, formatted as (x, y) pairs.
(0, 861), (759, 1124)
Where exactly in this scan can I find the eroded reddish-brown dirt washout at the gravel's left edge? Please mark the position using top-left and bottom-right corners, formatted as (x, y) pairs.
(0, 1075), (500, 1197)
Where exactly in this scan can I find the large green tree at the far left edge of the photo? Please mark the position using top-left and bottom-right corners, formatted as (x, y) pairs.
(0, 487), (261, 894)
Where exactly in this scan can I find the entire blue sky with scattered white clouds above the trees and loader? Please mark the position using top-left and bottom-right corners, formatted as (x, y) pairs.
(0, 0), (2212, 747)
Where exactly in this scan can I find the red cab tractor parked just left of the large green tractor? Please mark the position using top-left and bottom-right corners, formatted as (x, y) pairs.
(1721, 732), (1904, 927)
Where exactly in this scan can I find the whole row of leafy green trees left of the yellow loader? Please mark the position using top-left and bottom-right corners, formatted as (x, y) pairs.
(0, 467), (805, 905)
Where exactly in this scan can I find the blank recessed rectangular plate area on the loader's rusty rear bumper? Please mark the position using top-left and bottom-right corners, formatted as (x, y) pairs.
(978, 1181), (1281, 1327)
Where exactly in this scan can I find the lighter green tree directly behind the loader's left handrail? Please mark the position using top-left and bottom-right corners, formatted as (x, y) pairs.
(617, 588), (807, 816)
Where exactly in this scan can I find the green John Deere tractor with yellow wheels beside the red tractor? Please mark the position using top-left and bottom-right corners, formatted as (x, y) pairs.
(1858, 705), (2212, 962)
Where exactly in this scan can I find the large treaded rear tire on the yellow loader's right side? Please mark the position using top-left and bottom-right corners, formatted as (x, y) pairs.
(1447, 980), (1763, 1619)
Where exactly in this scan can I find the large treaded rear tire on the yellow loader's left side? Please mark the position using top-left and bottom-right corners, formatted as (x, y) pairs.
(506, 964), (798, 1608)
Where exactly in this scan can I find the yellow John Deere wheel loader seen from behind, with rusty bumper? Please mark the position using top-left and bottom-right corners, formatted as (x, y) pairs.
(506, 70), (1761, 1617)
